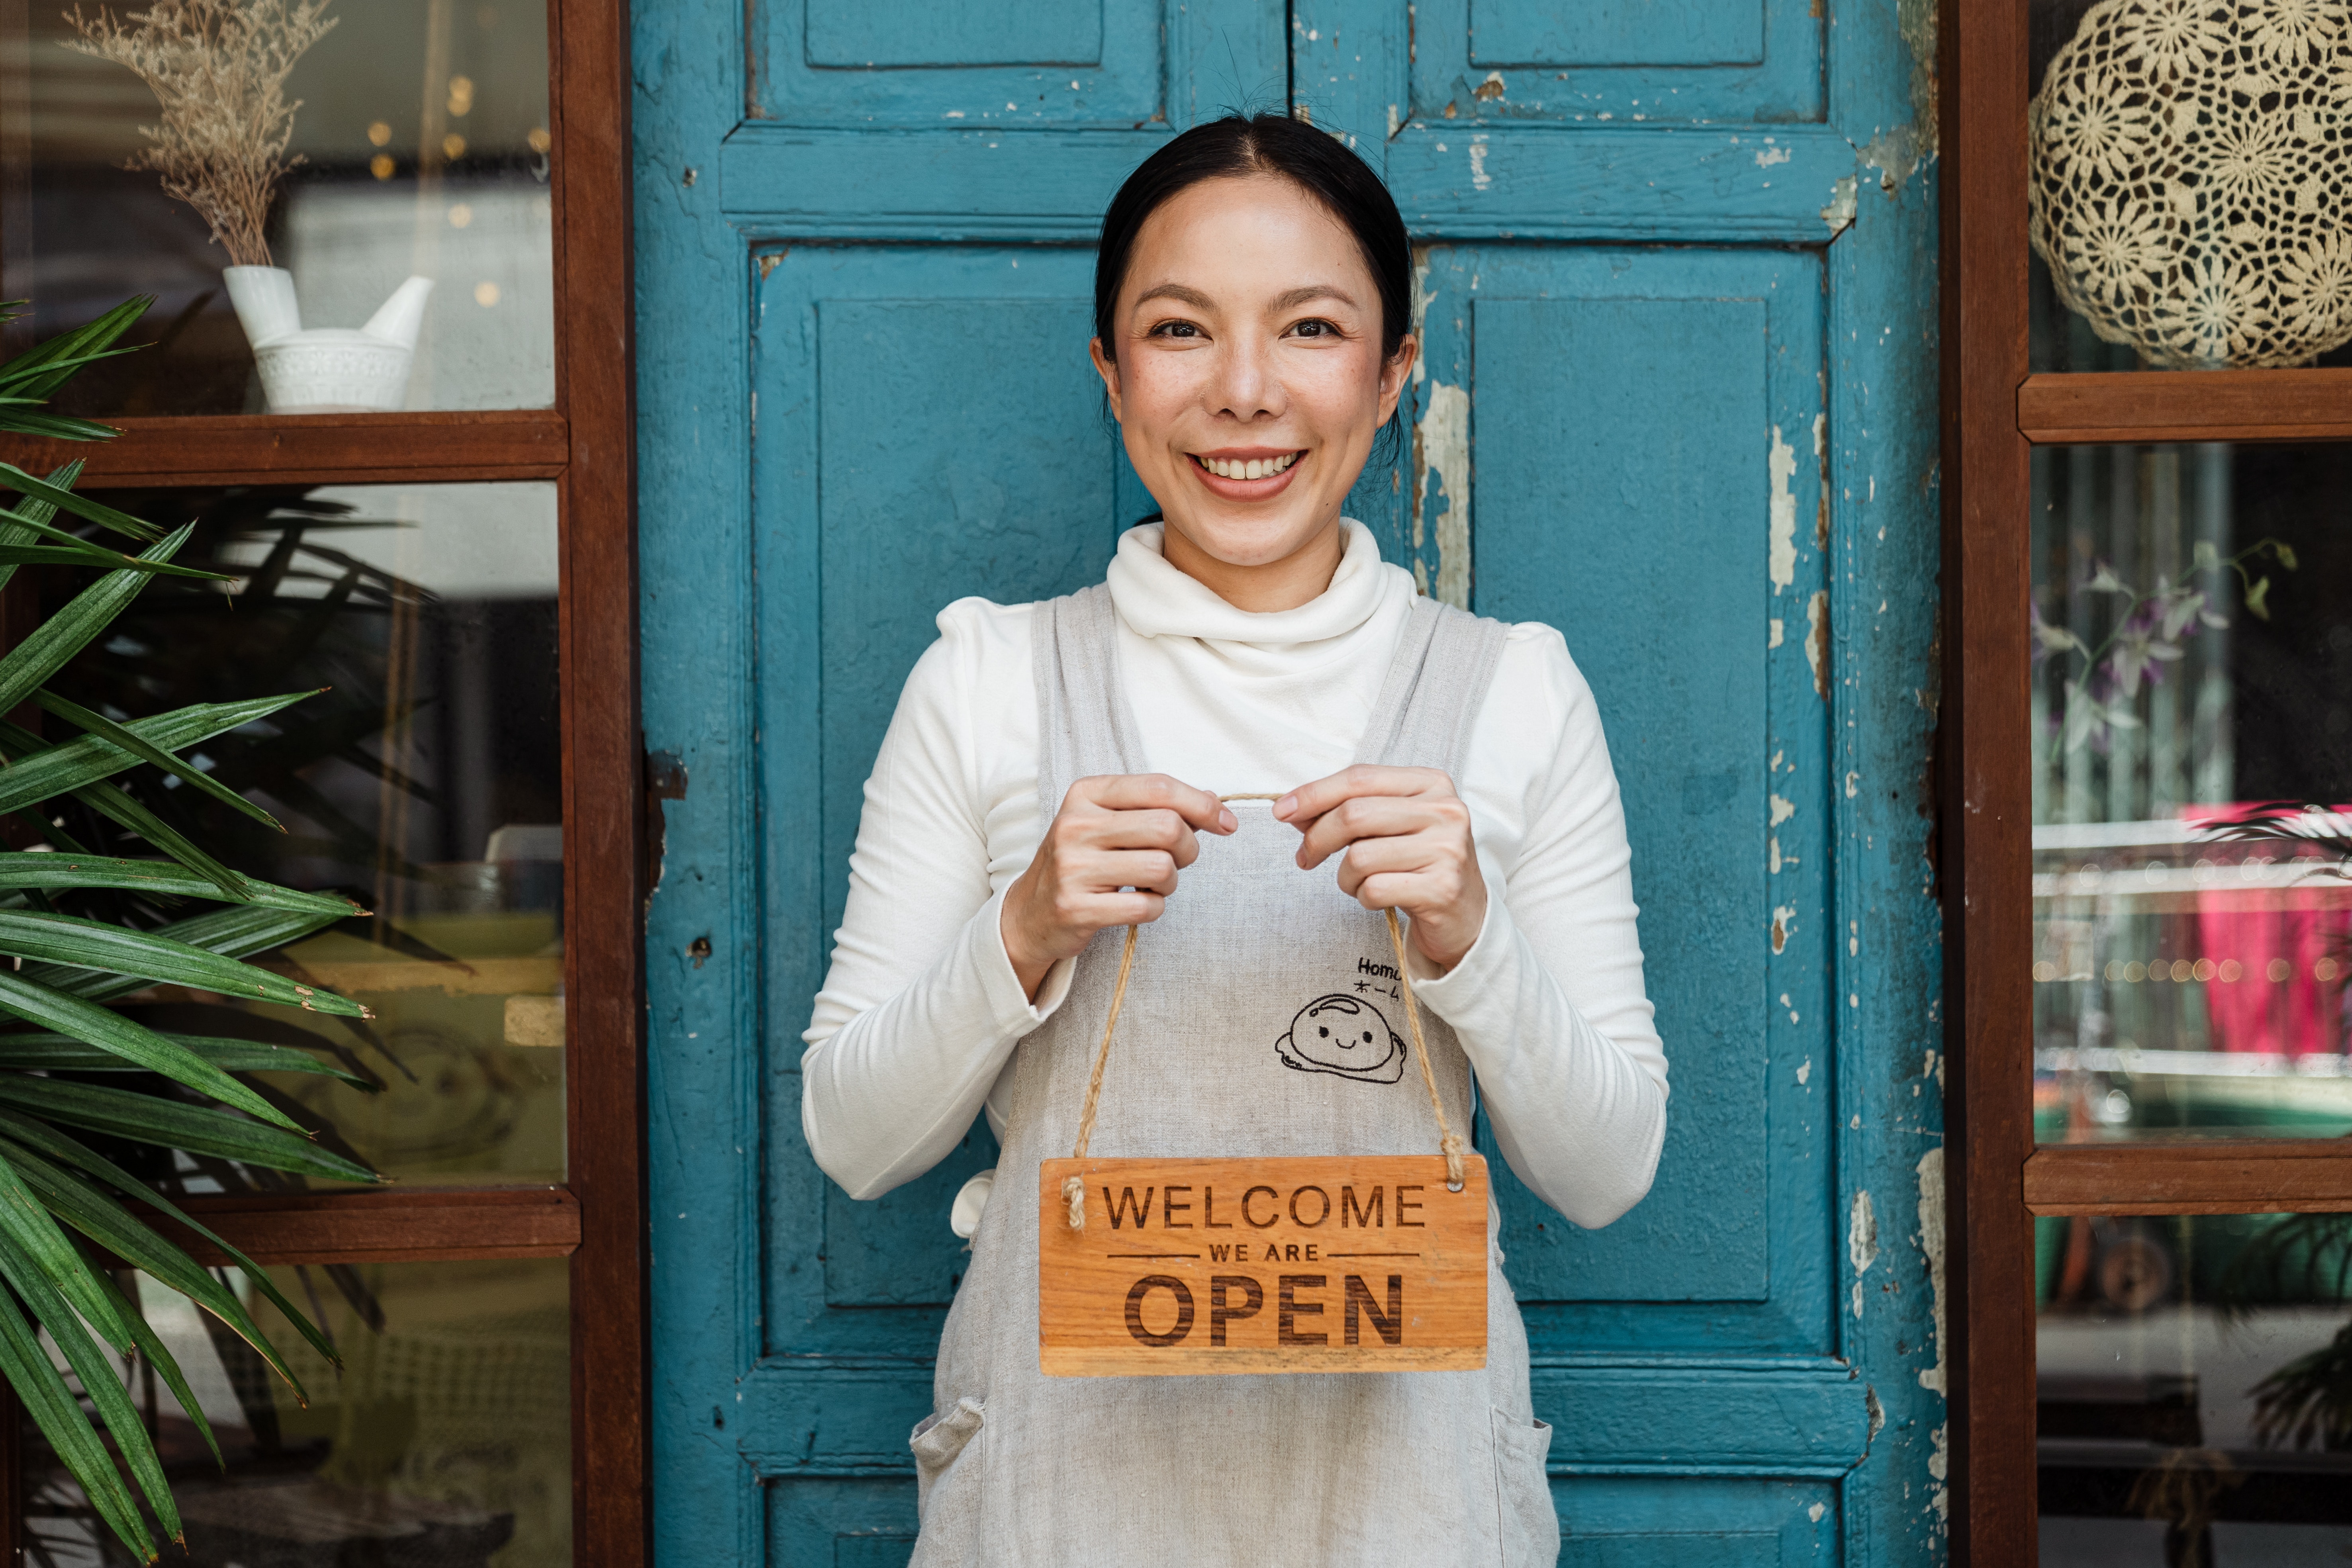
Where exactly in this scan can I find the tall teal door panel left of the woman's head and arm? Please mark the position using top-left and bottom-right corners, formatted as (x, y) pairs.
(753, 245), (1129, 1363)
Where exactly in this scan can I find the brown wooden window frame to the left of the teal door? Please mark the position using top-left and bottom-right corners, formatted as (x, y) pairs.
(0, 0), (652, 1568)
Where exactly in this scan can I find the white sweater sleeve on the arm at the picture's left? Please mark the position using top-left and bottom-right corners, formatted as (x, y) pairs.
(800, 599), (1070, 1199)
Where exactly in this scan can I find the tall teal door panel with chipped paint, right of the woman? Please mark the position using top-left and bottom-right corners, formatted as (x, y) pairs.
(1406, 247), (1835, 1352)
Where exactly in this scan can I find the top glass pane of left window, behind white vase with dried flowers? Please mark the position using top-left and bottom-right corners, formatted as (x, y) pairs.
(0, 0), (555, 416)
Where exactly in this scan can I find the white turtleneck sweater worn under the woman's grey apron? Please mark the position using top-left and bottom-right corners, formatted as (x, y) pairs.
(800, 522), (1665, 1227)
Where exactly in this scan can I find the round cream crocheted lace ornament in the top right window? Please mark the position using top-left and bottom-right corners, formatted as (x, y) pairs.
(2027, 0), (2352, 369)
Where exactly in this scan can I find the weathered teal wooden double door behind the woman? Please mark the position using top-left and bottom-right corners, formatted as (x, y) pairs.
(635, 0), (1947, 1568)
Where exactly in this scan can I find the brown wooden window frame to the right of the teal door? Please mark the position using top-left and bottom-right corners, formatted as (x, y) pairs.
(1938, 0), (2352, 1568)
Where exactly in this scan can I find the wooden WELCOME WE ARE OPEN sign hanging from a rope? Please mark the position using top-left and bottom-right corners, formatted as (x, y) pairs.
(1037, 1154), (1486, 1378)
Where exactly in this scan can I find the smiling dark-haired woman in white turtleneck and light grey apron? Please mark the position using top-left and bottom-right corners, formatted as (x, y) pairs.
(802, 115), (1665, 1568)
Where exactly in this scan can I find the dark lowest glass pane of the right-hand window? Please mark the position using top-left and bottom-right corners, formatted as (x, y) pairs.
(2035, 1213), (2352, 1568)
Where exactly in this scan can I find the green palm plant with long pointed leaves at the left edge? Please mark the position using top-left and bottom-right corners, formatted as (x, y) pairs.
(0, 299), (379, 1561)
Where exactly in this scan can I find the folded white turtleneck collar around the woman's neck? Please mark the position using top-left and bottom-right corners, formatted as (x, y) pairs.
(1110, 517), (1411, 651)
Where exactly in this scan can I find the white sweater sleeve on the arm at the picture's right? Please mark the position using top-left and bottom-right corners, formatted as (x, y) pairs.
(1414, 625), (1665, 1227)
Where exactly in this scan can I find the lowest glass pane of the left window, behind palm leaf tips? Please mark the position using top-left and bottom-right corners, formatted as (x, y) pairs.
(24, 1258), (572, 1568)
